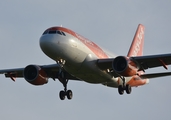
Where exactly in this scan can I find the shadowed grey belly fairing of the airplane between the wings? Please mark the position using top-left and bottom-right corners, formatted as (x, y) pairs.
(67, 54), (118, 87)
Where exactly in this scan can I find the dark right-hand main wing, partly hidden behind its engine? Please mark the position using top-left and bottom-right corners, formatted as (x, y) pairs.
(97, 54), (171, 76)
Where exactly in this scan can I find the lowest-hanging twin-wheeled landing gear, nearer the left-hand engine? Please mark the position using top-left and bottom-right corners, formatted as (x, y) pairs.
(58, 72), (73, 100)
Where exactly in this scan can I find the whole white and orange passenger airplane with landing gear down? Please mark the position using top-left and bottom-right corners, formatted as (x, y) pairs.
(0, 24), (171, 100)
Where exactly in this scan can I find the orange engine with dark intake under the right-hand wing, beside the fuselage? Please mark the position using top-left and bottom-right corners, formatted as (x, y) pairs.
(112, 56), (139, 77)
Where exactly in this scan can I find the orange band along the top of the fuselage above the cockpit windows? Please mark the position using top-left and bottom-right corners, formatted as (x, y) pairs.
(47, 27), (108, 58)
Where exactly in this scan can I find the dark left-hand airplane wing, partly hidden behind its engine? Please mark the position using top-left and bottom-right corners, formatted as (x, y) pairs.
(0, 64), (78, 81)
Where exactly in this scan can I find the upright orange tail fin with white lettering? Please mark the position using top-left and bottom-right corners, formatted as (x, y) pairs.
(127, 24), (145, 57)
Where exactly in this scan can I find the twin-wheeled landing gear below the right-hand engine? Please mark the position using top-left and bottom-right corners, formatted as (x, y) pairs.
(118, 77), (132, 95)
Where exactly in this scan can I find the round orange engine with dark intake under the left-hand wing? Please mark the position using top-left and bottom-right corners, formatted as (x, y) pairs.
(23, 65), (48, 85)
